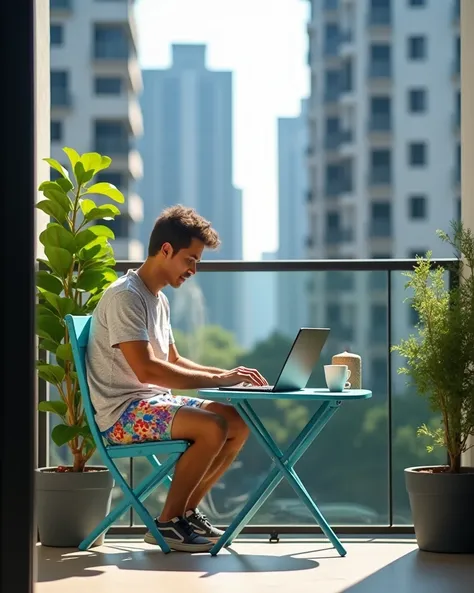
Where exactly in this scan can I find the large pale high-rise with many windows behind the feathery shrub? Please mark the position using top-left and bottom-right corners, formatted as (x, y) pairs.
(307, 0), (460, 389)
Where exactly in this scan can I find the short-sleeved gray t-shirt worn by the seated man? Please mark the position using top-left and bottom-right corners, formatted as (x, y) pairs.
(86, 270), (174, 431)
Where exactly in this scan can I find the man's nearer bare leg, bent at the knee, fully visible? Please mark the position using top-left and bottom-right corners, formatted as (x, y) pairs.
(159, 407), (228, 522)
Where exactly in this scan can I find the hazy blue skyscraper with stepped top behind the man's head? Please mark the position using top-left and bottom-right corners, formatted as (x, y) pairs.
(139, 44), (242, 336)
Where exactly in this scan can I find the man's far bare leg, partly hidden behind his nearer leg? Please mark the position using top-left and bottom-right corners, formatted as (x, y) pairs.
(186, 402), (249, 510)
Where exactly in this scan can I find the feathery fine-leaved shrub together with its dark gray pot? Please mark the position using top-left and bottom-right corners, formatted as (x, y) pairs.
(392, 222), (474, 553)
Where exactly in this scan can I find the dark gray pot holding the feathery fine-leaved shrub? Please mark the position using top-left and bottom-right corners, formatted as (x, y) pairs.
(405, 466), (474, 554)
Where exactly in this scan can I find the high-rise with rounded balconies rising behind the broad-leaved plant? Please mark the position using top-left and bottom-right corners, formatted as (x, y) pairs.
(50, 0), (143, 260)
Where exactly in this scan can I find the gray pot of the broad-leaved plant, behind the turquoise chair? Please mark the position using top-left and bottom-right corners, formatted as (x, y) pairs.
(36, 466), (114, 548)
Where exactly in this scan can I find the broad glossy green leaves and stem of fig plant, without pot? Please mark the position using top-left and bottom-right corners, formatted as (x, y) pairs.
(36, 147), (125, 472)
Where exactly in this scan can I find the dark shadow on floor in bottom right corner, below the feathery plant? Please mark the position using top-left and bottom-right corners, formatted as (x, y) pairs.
(341, 549), (474, 593)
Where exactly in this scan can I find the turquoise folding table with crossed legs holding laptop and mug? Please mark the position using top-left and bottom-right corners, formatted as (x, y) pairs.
(199, 389), (372, 556)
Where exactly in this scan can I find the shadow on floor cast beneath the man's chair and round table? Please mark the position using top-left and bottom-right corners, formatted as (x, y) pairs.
(37, 543), (321, 587)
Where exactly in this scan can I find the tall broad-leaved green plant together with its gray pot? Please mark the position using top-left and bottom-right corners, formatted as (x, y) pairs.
(36, 148), (124, 546)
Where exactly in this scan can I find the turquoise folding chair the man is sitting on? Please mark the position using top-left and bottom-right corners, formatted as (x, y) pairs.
(65, 315), (190, 554)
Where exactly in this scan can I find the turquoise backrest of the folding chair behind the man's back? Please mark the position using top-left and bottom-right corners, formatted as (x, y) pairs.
(65, 315), (105, 455)
